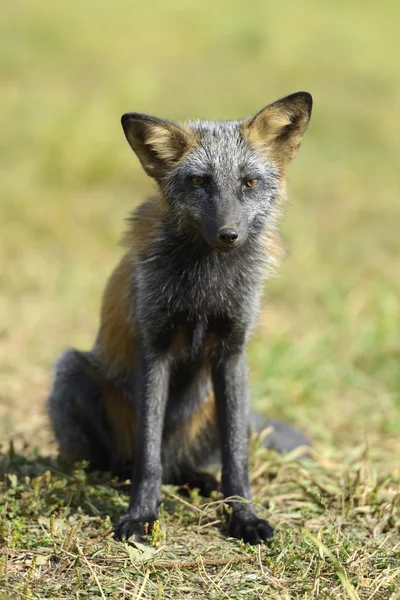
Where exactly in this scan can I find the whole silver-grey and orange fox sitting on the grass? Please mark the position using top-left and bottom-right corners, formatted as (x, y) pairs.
(48, 92), (313, 544)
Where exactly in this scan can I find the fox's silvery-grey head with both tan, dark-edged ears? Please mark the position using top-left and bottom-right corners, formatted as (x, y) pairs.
(121, 92), (312, 251)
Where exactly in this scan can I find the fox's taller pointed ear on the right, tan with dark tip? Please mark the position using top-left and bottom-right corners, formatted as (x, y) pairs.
(242, 92), (312, 167)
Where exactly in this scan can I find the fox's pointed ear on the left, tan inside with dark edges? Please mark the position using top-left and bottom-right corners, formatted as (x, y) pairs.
(121, 113), (195, 179)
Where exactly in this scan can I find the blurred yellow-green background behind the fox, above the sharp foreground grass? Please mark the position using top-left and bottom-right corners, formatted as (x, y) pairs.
(0, 0), (400, 450)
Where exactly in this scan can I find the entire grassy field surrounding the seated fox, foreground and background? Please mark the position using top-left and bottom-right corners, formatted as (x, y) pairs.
(0, 0), (400, 600)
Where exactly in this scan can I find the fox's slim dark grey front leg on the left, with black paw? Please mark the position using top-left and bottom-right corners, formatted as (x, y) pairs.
(114, 345), (169, 540)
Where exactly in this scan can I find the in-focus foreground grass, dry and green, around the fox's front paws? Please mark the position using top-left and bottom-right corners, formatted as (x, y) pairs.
(0, 442), (400, 600)
